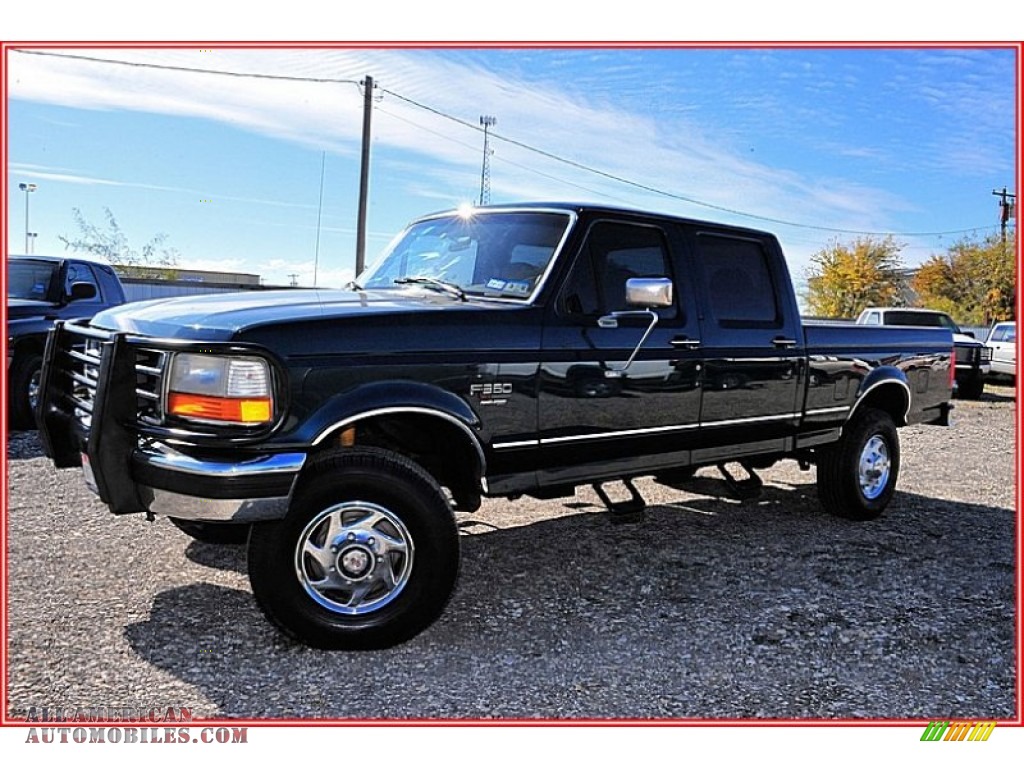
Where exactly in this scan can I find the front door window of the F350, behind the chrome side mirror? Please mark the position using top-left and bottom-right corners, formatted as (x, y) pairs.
(559, 221), (678, 318)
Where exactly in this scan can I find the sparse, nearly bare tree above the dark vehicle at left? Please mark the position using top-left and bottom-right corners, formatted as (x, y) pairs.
(58, 208), (178, 280)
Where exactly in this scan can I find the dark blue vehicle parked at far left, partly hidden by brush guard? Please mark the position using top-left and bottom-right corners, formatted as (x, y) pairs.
(7, 256), (125, 429)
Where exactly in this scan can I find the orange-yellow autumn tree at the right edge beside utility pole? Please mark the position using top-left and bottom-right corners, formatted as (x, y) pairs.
(910, 233), (1017, 326)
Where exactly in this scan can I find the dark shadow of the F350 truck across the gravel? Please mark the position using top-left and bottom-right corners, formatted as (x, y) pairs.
(125, 486), (1015, 719)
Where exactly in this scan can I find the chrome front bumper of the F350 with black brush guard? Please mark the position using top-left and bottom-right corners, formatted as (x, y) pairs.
(37, 323), (306, 522)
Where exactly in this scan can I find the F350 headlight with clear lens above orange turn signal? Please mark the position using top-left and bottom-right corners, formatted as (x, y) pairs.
(167, 353), (273, 426)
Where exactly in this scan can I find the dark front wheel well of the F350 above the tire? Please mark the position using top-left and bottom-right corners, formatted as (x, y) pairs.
(317, 412), (483, 512)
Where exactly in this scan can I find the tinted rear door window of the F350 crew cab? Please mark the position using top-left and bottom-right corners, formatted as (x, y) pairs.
(697, 233), (781, 328)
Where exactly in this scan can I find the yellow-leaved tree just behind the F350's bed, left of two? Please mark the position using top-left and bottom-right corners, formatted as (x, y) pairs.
(807, 237), (906, 317)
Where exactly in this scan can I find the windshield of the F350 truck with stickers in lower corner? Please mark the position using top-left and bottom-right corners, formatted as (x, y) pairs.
(357, 211), (569, 299)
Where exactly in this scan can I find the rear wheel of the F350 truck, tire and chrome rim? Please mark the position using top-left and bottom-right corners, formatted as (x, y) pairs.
(817, 409), (900, 520)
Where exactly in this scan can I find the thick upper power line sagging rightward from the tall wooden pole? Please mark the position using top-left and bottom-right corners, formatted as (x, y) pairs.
(12, 48), (988, 238)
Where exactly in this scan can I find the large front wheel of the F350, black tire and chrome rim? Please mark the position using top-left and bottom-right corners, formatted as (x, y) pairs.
(249, 447), (459, 650)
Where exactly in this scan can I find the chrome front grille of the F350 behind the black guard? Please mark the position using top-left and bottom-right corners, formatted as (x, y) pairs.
(59, 326), (168, 431)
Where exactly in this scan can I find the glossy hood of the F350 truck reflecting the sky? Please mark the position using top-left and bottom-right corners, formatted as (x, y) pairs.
(92, 288), (487, 341)
